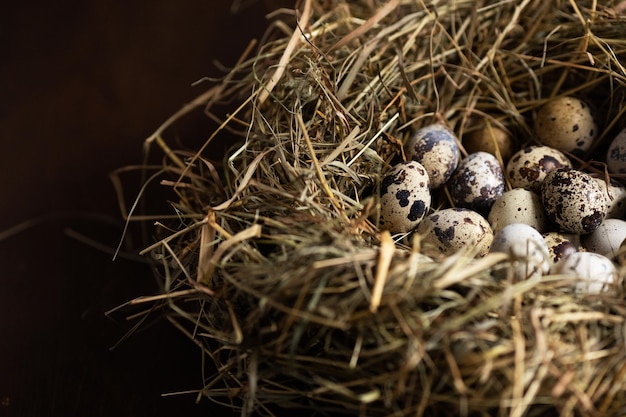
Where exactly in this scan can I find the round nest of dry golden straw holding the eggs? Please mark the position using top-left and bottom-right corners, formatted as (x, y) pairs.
(117, 0), (626, 416)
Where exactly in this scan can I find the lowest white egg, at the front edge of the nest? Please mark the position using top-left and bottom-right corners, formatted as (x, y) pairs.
(556, 252), (617, 294)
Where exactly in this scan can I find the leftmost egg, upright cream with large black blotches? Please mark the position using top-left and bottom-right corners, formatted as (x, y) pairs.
(380, 161), (431, 233)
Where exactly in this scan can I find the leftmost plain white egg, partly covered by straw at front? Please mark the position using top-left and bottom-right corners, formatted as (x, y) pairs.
(490, 223), (550, 281)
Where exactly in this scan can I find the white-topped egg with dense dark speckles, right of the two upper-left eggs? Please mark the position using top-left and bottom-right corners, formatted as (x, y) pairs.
(448, 152), (504, 215)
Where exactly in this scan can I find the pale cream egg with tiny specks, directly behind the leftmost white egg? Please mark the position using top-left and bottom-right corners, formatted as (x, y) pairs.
(487, 188), (548, 233)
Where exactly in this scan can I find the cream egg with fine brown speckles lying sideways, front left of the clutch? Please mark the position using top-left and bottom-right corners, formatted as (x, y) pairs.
(416, 208), (493, 256)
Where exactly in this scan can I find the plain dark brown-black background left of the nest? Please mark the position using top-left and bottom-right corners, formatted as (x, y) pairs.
(0, 0), (293, 416)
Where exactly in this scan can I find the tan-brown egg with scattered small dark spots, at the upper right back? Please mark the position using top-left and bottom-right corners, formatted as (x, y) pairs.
(535, 96), (598, 157)
